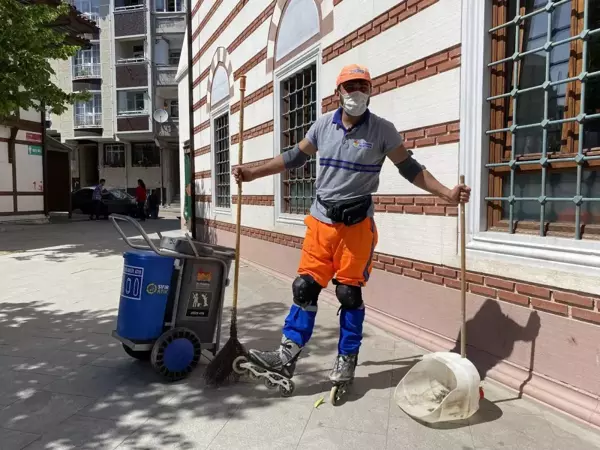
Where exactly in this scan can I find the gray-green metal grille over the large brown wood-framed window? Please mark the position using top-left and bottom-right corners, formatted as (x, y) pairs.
(485, 0), (600, 239)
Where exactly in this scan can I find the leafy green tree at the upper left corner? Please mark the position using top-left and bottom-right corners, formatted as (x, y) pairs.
(0, 0), (89, 119)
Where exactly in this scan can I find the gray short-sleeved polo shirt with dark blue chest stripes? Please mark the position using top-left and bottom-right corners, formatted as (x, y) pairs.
(306, 108), (402, 223)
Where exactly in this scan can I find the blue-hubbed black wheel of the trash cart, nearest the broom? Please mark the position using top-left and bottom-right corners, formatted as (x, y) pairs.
(150, 328), (202, 381)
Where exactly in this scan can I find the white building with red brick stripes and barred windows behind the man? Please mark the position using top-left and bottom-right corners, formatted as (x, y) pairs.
(179, 0), (600, 425)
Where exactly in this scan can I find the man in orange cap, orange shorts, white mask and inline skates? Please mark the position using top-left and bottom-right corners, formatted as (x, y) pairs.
(233, 64), (470, 390)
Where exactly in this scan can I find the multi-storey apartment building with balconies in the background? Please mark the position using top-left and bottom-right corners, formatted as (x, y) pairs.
(48, 0), (185, 203)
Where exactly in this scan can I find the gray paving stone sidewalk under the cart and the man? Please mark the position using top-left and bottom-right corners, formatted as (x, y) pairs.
(0, 220), (600, 450)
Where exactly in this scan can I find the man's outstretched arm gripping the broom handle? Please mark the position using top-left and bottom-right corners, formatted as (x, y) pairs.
(233, 138), (317, 182)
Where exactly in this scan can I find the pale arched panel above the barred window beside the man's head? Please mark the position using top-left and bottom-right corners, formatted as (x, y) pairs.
(275, 0), (321, 61)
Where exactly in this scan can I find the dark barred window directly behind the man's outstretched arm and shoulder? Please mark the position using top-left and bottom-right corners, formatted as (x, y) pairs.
(280, 64), (318, 214)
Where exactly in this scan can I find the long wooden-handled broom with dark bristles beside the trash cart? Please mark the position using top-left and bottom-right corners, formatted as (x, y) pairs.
(204, 75), (246, 386)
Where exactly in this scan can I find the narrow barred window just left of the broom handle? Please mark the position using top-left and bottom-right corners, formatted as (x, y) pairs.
(215, 113), (229, 208)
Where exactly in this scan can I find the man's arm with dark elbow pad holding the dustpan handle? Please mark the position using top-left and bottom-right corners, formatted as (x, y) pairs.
(387, 144), (471, 203)
